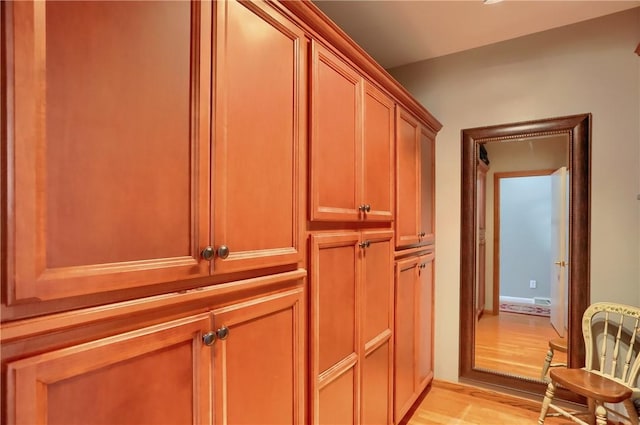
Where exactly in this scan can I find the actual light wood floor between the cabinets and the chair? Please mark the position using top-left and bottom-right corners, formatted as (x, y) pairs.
(403, 380), (573, 425)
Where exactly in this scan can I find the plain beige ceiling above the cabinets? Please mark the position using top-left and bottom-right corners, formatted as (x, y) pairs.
(313, 0), (640, 69)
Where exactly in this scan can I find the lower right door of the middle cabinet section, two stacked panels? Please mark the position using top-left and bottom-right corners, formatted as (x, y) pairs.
(361, 231), (393, 424)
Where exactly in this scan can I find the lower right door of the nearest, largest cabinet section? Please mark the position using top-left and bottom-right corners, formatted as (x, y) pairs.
(213, 287), (305, 425)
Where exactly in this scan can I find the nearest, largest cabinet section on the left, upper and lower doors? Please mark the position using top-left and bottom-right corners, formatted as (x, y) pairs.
(0, 1), (308, 424)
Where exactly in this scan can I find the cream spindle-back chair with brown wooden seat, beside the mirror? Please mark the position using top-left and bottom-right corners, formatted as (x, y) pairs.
(538, 303), (640, 425)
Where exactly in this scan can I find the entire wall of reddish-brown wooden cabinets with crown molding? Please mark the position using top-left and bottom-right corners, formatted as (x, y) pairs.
(0, 0), (441, 424)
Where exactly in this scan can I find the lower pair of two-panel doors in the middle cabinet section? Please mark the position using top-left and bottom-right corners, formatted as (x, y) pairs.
(310, 231), (393, 424)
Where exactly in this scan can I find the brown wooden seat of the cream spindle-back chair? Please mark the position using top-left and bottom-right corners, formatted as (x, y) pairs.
(550, 369), (633, 403)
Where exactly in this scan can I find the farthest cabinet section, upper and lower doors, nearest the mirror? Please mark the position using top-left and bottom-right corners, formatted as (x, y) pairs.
(394, 108), (435, 423)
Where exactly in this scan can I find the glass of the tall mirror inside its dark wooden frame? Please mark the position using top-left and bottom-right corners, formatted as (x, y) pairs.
(475, 134), (570, 379)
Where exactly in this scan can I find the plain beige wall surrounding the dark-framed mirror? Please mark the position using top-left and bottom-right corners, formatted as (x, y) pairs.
(390, 8), (640, 381)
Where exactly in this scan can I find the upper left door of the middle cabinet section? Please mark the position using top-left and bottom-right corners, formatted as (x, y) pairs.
(309, 41), (362, 221)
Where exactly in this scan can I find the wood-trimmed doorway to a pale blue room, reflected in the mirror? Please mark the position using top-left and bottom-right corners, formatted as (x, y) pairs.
(492, 169), (554, 317)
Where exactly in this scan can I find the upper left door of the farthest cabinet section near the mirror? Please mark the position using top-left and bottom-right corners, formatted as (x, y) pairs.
(395, 107), (422, 248)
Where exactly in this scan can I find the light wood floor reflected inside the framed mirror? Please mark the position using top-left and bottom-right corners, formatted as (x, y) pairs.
(475, 312), (567, 379)
